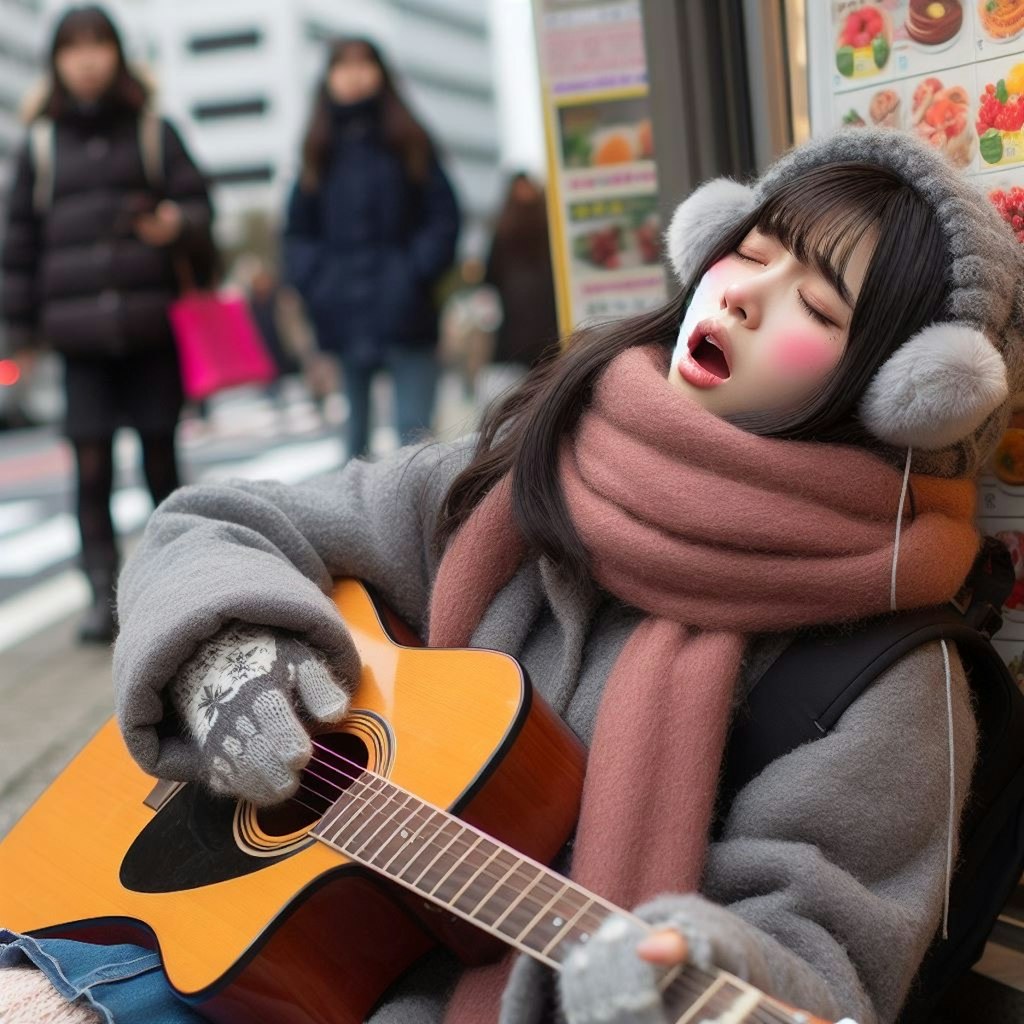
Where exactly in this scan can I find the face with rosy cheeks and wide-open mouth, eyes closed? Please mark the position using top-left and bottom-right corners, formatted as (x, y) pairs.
(669, 229), (874, 417)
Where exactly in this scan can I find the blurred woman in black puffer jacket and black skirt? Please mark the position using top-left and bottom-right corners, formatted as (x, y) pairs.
(2, 6), (213, 642)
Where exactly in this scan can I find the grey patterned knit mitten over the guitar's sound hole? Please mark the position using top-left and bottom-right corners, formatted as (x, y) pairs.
(169, 623), (359, 806)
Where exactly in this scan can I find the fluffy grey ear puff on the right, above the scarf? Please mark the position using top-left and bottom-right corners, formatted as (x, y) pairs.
(860, 323), (1009, 451)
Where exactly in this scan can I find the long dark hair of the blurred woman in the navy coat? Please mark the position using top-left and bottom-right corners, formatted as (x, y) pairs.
(301, 36), (434, 191)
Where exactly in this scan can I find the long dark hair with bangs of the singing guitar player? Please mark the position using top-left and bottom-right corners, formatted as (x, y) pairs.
(435, 163), (947, 583)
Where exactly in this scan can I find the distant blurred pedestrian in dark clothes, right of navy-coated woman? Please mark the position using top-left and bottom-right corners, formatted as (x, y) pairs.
(477, 171), (558, 409)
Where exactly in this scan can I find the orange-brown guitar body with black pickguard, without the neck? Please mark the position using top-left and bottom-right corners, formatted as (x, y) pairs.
(0, 580), (585, 1024)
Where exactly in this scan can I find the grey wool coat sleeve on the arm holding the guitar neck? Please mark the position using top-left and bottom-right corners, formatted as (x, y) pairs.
(640, 643), (977, 1024)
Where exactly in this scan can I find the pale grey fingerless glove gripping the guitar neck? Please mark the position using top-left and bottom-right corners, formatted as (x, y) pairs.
(559, 914), (711, 1024)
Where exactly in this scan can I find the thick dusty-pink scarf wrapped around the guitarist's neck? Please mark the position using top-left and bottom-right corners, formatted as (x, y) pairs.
(429, 347), (978, 1024)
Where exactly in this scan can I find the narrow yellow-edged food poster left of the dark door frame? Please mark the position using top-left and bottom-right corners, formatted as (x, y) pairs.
(534, 0), (668, 334)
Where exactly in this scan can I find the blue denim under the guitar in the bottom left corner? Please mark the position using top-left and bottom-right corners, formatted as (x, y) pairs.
(0, 929), (204, 1024)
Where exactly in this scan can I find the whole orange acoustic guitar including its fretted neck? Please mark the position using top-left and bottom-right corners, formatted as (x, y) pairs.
(0, 580), (843, 1024)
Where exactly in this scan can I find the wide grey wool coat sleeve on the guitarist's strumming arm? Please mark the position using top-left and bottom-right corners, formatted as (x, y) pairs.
(114, 439), (473, 777)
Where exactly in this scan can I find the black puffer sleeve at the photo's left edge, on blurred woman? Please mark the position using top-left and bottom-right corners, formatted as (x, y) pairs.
(0, 143), (42, 351)
